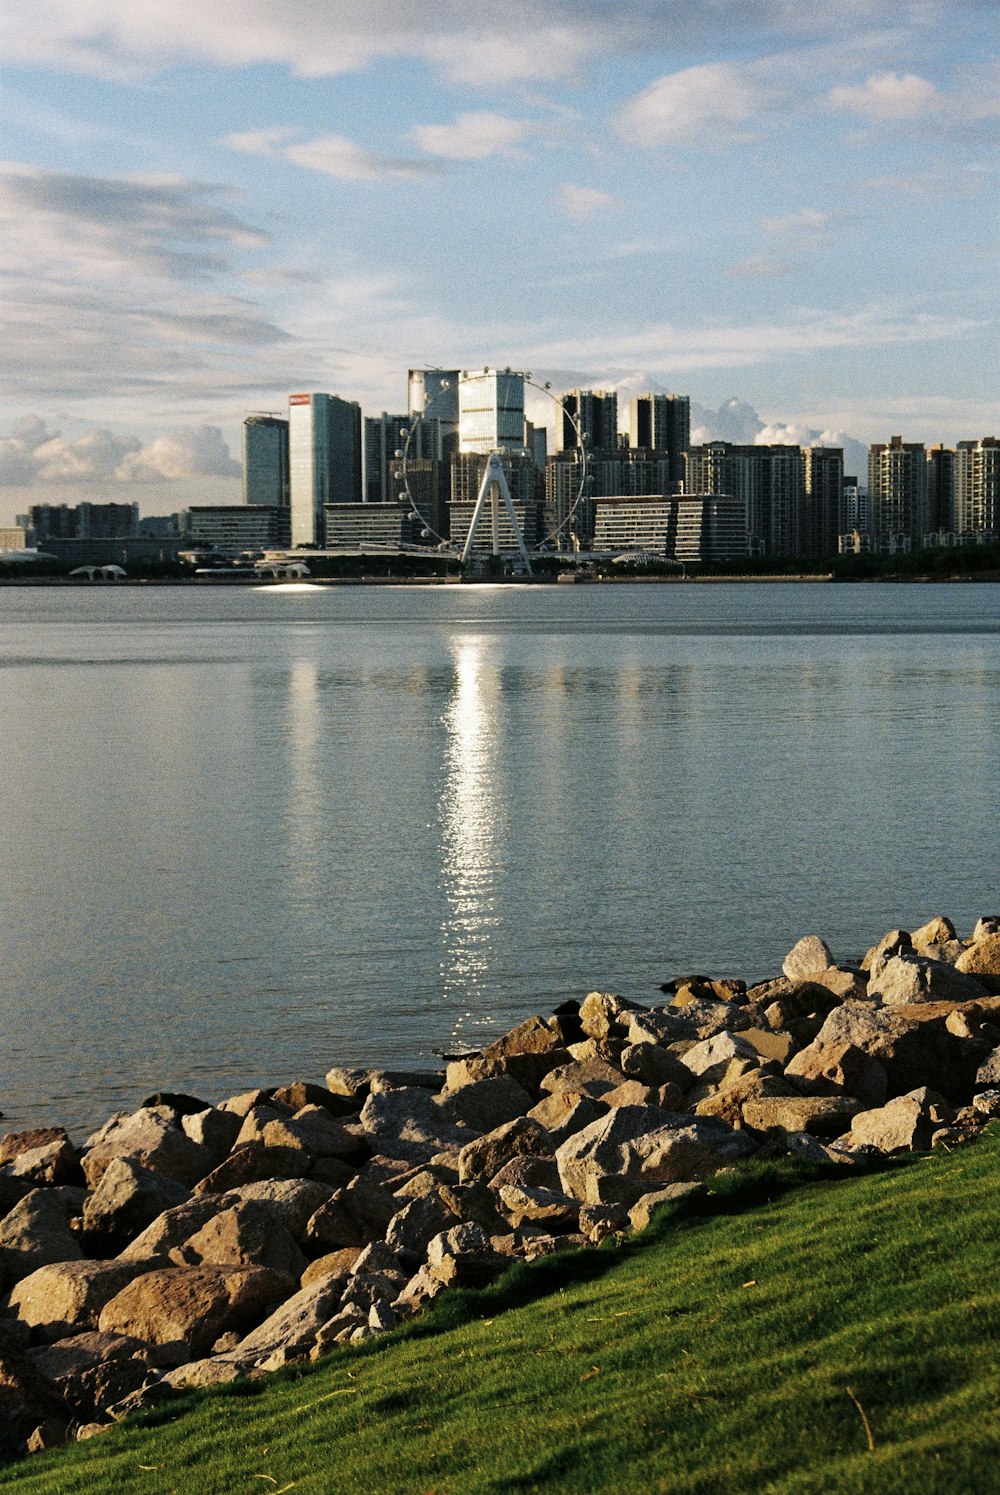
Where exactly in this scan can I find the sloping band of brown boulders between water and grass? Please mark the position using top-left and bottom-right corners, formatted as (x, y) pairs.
(0, 915), (1000, 1459)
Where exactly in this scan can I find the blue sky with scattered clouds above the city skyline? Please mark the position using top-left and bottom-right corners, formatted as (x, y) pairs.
(0, 0), (1000, 523)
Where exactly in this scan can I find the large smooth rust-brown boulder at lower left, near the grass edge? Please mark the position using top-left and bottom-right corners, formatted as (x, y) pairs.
(99, 1266), (291, 1359)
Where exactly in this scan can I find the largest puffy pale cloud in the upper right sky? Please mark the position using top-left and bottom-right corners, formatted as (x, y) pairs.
(614, 63), (779, 147)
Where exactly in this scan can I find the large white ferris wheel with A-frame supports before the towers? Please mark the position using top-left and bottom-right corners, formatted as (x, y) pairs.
(393, 368), (589, 574)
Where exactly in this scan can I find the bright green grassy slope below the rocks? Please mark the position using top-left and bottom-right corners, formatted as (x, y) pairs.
(0, 1127), (1000, 1495)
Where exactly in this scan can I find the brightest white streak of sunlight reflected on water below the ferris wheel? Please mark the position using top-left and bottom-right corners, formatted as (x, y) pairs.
(439, 638), (502, 1048)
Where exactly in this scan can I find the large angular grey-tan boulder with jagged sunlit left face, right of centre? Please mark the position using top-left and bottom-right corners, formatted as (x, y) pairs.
(556, 1106), (753, 1208)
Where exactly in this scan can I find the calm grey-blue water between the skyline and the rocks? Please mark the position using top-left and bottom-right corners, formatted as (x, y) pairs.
(0, 583), (1000, 1132)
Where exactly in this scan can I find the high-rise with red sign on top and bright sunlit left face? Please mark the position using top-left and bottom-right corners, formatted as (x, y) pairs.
(288, 395), (362, 546)
